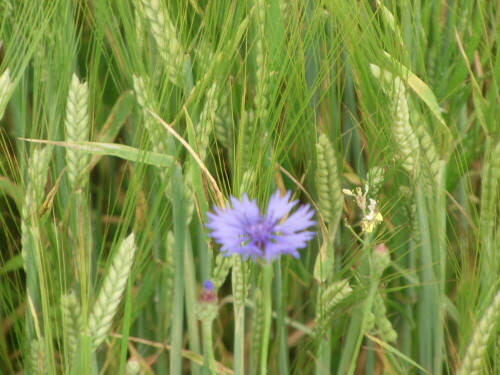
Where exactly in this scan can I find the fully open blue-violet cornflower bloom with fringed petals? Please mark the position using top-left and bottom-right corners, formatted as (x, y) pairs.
(206, 190), (315, 262)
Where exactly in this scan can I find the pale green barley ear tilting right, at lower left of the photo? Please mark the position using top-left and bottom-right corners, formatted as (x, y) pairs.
(88, 233), (136, 349)
